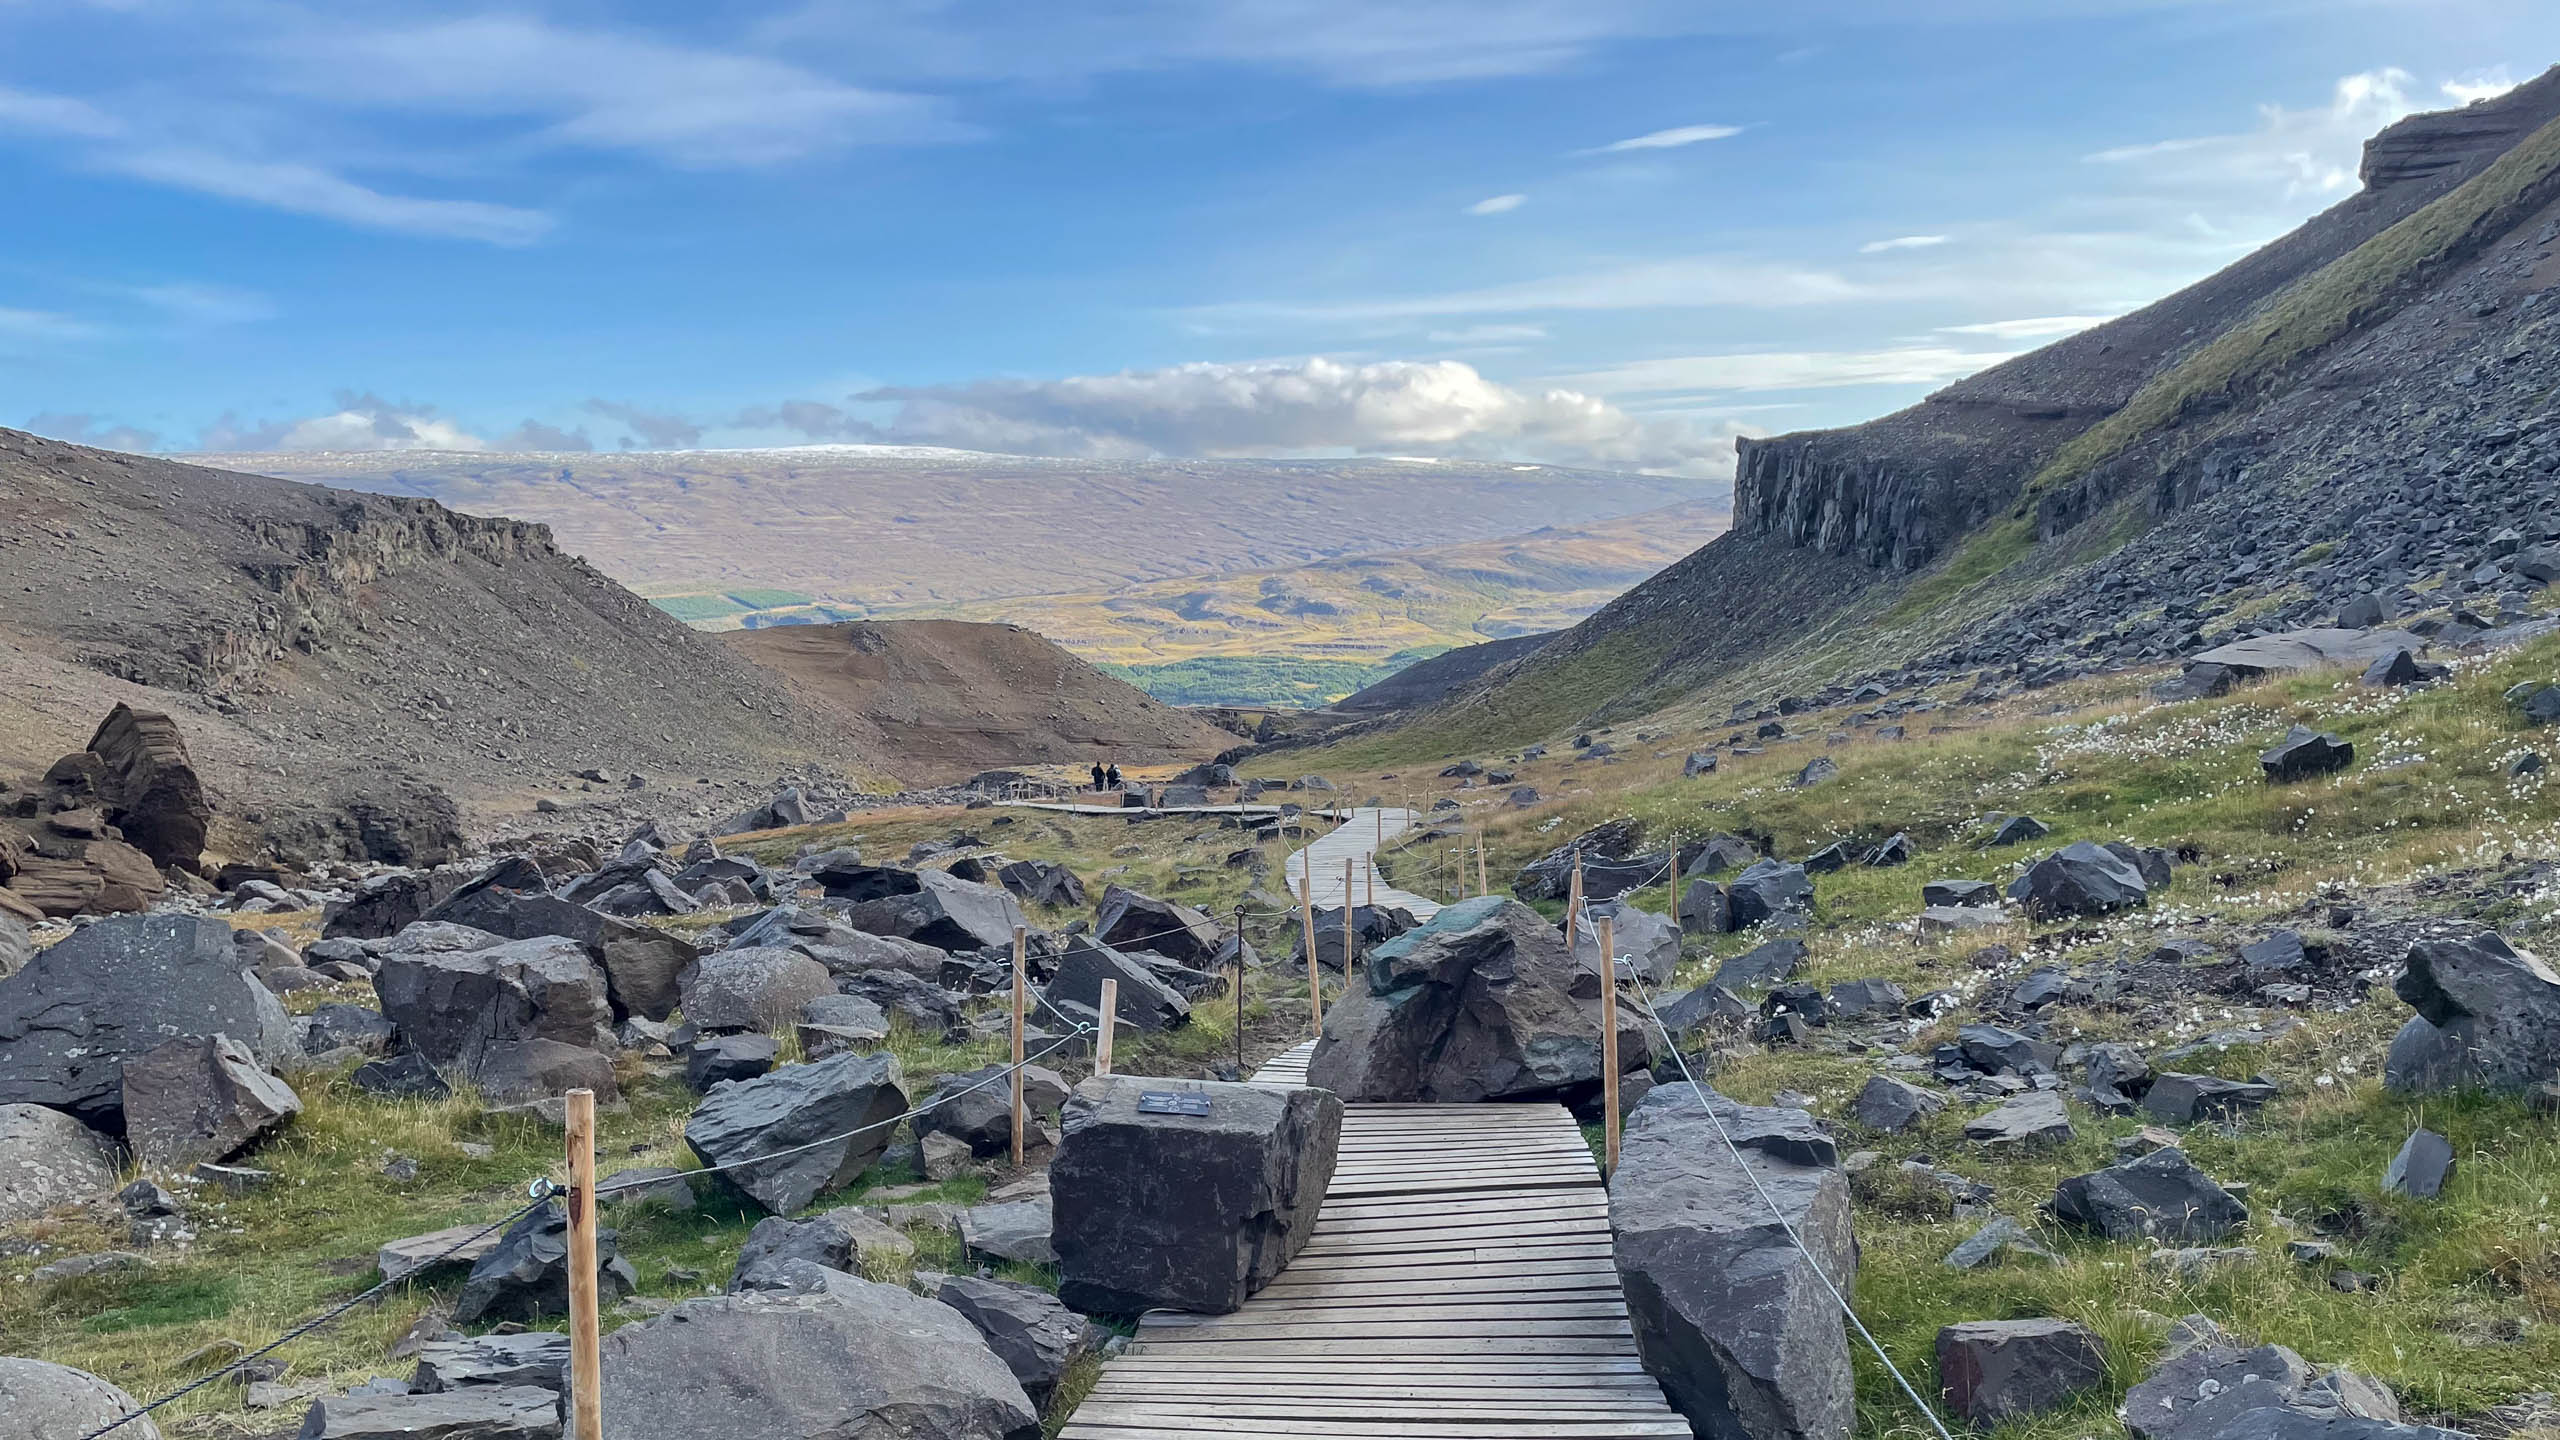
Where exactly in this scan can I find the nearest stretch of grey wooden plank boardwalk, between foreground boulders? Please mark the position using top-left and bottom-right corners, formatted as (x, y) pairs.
(1062, 1043), (1690, 1440)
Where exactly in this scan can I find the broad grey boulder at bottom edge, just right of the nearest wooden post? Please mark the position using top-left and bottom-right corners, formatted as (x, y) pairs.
(602, 1266), (1039, 1440)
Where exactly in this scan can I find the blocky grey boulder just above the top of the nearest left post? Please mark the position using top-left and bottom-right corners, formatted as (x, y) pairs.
(374, 935), (612, 1076)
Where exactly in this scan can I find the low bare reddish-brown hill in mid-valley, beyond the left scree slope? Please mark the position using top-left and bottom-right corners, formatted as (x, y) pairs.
(719, 620), (1236, 784)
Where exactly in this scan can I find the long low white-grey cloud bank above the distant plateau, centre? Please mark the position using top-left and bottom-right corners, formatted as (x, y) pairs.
(852, 356), (1731, 474)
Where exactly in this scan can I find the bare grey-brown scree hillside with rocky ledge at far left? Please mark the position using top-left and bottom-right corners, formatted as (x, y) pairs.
(0, 430), (868, 861)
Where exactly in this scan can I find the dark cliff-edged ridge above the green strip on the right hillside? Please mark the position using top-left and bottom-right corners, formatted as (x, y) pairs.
(1733, 69), (2560, 571)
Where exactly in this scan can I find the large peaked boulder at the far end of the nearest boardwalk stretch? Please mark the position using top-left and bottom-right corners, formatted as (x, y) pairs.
(1308, 894), (1649, 1102)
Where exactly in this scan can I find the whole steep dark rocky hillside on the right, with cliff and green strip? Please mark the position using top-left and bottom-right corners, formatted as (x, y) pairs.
(1372, 72), (2560, 743)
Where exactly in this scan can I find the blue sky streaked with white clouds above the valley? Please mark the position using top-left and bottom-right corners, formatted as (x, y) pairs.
(0, 0), (2560, 474)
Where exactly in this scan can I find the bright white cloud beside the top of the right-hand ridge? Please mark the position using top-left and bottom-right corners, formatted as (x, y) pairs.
(2086, 69), (2417, 197)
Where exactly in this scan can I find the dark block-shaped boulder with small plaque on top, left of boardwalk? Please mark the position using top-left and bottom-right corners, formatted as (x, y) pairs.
(1050, 1076), (1341, 1314)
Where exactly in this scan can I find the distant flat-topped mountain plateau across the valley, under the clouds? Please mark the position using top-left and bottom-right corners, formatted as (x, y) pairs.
(200, 446), (1725, 702)
